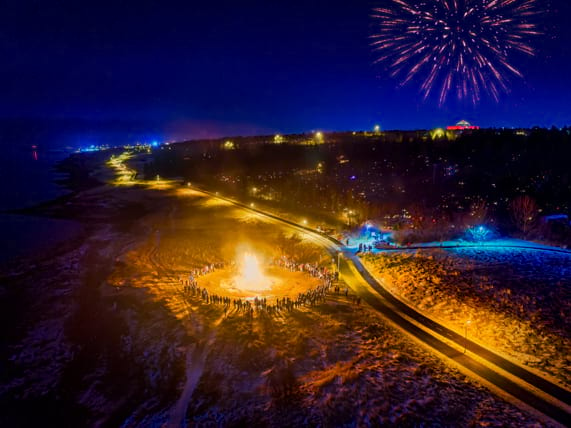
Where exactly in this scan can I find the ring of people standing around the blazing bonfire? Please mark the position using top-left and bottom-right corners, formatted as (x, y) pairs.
(180, 256), (358, 317)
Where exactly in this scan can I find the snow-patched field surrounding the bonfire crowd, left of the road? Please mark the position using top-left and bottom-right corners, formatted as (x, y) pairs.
(0, 155), (560, 427)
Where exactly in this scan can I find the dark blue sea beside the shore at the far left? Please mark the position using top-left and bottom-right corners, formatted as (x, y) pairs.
(0, 119), (161, 266)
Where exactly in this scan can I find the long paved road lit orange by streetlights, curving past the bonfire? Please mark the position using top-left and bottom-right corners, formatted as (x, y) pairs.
(189, 188), (571, 426)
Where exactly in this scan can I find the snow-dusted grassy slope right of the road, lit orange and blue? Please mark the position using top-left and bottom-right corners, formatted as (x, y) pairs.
(363, 244), (571, 385)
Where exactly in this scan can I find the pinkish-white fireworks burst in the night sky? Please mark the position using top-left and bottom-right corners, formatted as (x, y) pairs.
(372, 0), (540, 105)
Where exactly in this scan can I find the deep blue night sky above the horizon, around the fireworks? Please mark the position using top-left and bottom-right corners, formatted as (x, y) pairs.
(0, 0), (571, 137)
